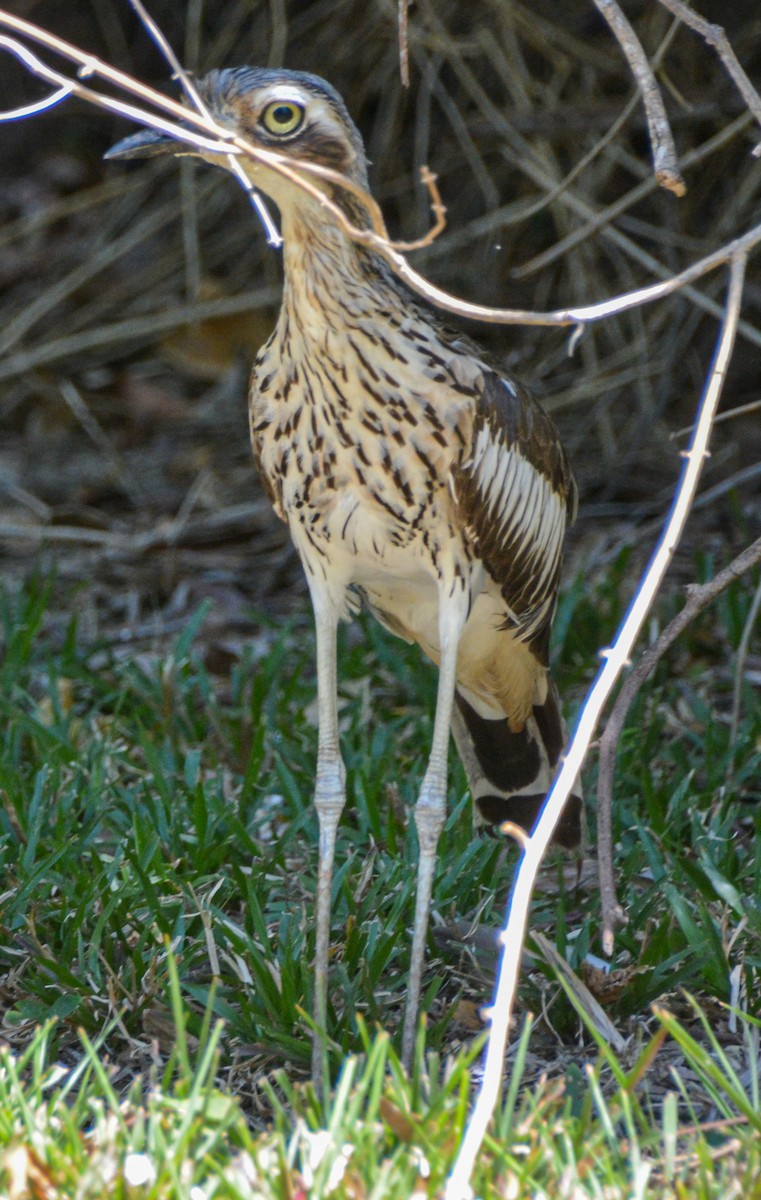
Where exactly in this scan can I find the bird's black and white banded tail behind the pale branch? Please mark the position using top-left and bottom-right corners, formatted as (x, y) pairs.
(451, 679), (581, 847)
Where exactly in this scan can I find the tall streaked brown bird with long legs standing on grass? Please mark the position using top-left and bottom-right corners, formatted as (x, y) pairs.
(107, 66), (582, 1082)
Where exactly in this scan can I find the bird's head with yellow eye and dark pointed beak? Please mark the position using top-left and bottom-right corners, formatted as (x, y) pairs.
(106, 67), (367, 211)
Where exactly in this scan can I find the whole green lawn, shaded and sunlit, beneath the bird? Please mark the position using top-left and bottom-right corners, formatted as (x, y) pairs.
(0, 556), (761, 1200)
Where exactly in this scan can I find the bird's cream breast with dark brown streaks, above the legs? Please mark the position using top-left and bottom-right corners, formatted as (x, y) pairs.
(251, 331), (472, 575)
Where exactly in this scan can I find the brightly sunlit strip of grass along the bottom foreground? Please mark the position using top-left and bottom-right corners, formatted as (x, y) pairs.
(0, 972), (761, 1200)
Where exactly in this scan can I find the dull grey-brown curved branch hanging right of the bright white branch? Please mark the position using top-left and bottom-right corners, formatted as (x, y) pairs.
(598, 538), (761, 954)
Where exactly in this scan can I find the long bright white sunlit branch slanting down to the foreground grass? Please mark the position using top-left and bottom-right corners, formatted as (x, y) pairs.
(444, 253), (747, 1200)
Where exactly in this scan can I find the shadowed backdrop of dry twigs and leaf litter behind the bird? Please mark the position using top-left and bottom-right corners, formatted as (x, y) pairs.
(0, 0), (761, 636)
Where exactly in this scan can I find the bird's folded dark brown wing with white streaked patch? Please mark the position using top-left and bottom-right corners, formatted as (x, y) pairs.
(451, 370), (576, 662)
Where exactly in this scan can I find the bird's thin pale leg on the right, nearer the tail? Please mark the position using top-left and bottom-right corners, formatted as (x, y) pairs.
(402, 580), (469, 1069)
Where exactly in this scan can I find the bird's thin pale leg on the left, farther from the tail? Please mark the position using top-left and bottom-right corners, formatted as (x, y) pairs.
(311, 587), (346, 1091)
